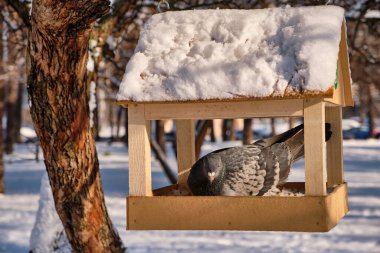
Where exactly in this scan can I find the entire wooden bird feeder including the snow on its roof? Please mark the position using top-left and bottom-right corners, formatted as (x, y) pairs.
(118, 6), (353, 232)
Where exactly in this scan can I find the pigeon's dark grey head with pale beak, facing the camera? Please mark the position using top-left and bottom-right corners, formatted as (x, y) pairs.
(202, 153), (224, 184)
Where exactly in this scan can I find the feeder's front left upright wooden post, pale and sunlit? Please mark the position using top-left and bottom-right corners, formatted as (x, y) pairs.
(128, 104), (152, 196)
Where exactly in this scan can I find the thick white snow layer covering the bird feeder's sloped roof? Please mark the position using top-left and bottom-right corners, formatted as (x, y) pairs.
(117, 6), (344, 102)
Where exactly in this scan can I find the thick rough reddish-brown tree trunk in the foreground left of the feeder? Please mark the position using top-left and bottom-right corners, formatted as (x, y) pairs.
(28, 0), (124, 252)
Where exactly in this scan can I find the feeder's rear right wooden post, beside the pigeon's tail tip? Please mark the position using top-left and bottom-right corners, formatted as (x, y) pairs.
(326, 106), (344, 186)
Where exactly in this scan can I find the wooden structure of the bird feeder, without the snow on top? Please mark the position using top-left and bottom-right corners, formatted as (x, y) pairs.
(119, 6), (353, 232)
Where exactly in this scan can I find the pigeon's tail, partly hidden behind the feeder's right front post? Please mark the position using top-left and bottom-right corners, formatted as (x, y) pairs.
(284, 123), (332, 161)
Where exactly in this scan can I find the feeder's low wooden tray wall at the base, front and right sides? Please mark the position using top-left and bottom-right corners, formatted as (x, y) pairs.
(127, 184), (347, 232)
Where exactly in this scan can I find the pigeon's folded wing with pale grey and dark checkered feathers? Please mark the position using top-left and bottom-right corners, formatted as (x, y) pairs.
(223, 145), (279, 196)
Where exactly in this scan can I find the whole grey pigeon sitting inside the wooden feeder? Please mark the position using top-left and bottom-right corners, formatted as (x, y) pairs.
(187, 123), (332, 196)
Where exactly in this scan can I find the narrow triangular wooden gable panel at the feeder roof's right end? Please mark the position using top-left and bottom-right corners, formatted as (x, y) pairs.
(339, 20), (354, 106)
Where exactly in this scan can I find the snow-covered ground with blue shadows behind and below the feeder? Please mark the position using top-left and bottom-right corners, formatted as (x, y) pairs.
(0, 140), (380, 253)
